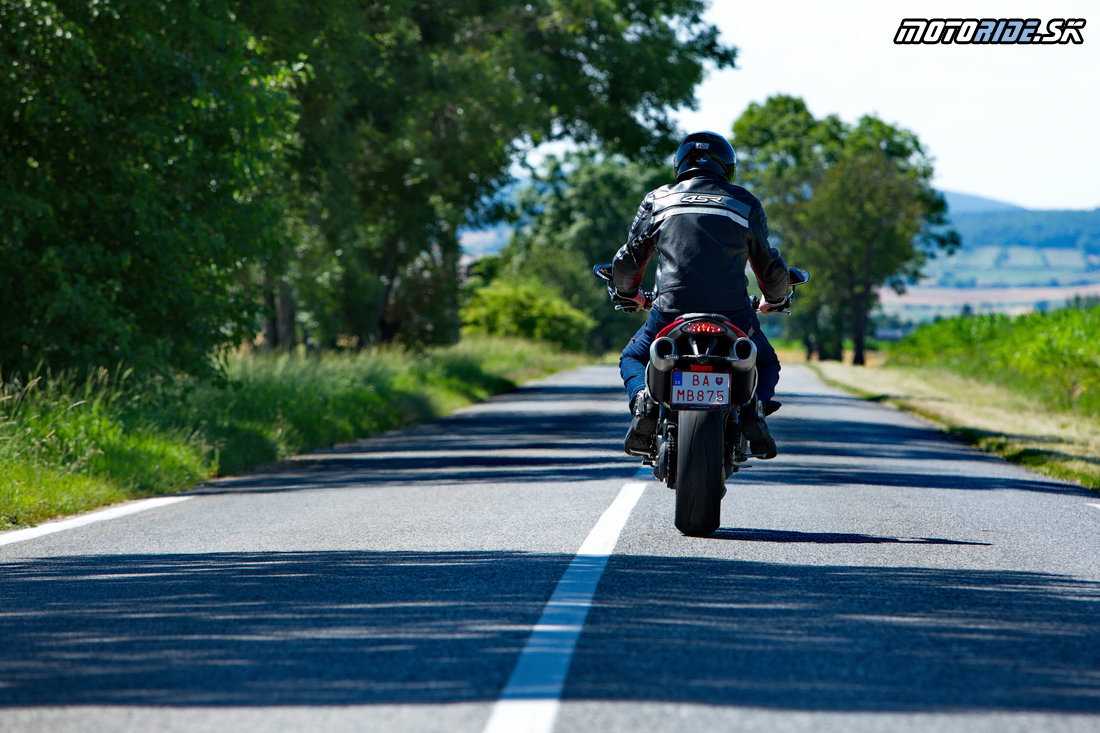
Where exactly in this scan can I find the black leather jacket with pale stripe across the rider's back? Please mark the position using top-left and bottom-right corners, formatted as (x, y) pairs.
(612, 171), (788, 313)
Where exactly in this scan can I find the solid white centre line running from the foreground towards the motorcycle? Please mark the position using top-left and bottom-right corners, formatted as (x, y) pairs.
(484, 469), (647, 733)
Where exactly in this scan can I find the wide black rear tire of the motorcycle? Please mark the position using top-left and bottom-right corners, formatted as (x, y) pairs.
(675, 409), (726, 537)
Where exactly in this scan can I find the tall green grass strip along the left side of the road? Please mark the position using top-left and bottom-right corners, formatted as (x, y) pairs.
(0, 338), (587, 529)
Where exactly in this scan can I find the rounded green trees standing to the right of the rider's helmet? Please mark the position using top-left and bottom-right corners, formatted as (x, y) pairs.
(734, 96), (959, 363)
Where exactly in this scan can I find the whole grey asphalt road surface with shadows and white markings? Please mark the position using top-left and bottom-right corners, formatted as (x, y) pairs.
(0, 367), (1100, 733)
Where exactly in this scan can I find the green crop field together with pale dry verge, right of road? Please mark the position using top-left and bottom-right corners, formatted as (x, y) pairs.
(810, 307), (1100, 489)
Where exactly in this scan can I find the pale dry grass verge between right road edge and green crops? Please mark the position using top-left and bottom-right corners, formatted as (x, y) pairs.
(807, 362), (1100, 490)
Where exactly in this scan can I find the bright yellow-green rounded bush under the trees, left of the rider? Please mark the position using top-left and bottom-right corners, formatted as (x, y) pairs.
(462, 281), (595, 351)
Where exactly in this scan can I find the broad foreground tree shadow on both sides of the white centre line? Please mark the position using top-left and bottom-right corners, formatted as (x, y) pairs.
(0, 550), (1100, 712)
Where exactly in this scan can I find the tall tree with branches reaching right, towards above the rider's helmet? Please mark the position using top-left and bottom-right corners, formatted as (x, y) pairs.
(239, 0), (734, 343)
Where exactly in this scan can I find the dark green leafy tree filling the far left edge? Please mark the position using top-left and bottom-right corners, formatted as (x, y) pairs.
(0, 0), (296, 374)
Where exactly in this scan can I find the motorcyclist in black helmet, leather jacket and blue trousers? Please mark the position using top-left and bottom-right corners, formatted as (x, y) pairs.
(612, 131), (789, 458)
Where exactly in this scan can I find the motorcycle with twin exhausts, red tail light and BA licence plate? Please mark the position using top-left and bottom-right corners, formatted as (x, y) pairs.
(592, 259), (810, 537)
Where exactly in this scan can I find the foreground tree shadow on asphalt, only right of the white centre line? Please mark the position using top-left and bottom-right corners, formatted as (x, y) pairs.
(569, 557), (1100, 711)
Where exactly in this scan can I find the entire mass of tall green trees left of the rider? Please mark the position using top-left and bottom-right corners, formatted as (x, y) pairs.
(0, 0), (734, 373)
